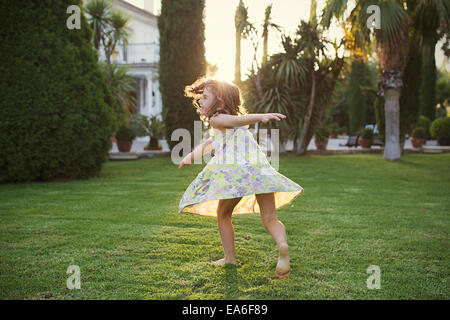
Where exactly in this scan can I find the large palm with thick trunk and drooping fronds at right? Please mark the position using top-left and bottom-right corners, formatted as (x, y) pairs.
(321, 0), (410, 160)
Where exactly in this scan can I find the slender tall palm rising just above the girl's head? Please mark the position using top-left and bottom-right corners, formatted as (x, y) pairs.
(234, 0), (255, 84)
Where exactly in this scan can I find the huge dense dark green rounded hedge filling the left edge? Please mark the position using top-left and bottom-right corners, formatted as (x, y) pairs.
(0, 0), (116, 182)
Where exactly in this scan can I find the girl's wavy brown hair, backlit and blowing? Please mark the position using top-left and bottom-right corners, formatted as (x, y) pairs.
(184, 77), (248, 123)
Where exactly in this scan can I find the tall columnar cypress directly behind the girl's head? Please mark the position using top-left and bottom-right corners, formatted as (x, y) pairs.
(158, 0), (206, 149)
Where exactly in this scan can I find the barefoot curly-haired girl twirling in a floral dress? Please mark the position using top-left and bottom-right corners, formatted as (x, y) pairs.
(178, 78), (303, 278)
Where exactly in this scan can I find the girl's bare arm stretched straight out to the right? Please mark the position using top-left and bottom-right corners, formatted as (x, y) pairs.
(209, 113), (286, 128)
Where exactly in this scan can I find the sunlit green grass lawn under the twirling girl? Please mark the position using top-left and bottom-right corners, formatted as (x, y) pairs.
(0, 154), (450, 299)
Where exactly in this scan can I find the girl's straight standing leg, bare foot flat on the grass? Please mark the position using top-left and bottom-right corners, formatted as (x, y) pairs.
(211, 197), (242, 266)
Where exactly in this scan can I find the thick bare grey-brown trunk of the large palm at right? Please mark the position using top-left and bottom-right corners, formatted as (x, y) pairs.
(383, 87), (401, 160)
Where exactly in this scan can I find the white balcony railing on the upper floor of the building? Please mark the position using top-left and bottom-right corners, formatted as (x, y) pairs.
(113, 42), (159, 64)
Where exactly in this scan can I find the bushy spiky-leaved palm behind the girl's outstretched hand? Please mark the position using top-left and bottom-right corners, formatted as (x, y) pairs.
(244, 21), (343, 154)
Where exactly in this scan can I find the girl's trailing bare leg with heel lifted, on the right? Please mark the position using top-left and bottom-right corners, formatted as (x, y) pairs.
(256, 192), (290, 278)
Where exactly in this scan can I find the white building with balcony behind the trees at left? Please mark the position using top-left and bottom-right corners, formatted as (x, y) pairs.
(97, 0), (162, 141)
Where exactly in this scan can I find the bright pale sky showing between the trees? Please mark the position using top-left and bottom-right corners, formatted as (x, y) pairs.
(127, 0), (450, 81)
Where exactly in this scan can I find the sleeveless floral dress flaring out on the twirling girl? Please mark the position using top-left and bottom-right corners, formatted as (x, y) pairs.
(179, 125), (303, 217)
